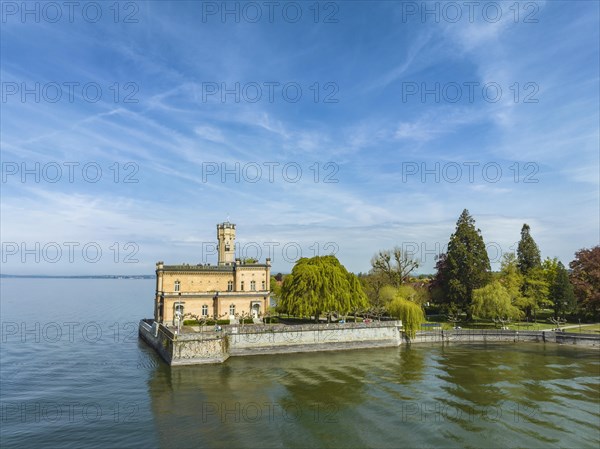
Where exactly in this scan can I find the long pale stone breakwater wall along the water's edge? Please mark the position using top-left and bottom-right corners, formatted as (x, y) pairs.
(139, 320), (600, 365)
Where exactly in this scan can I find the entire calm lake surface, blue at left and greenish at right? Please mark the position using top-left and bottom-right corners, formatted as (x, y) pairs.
(0, 279), (600, 448)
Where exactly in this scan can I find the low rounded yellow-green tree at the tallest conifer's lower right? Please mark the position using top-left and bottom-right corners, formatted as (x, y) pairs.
(471, 281), (521, 321)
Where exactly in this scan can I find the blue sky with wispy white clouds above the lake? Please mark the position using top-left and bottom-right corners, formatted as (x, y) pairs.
(0, 1), (600, 274)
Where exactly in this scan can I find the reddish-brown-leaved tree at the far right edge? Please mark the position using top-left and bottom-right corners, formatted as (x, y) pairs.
(569, 246), (600, 320)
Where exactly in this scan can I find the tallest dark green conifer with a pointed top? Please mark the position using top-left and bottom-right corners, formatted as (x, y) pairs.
(441, 209), (491, 320)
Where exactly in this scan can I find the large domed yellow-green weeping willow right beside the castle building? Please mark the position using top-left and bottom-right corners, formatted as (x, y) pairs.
(280, 256), (368, 321)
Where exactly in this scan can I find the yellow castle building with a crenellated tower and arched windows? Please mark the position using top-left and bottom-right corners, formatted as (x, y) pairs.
(154, 222), (271, 324)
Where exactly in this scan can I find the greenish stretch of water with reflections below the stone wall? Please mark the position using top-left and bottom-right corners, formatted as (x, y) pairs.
(148, 344), (600, 448)
